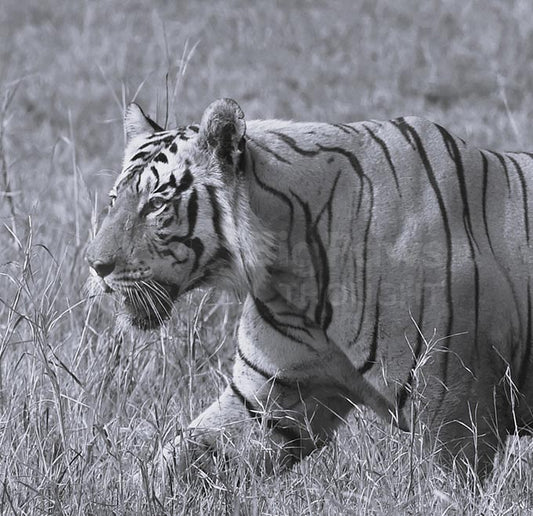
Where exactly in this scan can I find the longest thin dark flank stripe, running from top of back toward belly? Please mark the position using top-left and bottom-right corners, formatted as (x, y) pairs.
(393, 118), (453, 406)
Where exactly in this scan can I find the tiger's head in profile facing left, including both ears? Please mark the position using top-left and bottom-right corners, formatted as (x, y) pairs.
(87, 99), (268, 329)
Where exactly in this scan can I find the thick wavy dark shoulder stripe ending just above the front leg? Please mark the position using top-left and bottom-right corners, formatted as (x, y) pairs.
(291, 191), (333, 330)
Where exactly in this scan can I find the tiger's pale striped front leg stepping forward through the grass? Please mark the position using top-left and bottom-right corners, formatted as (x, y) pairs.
(160, 293), (407, 484)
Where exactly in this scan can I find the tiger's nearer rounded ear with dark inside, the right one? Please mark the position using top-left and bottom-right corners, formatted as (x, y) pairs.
(198, 99), (246, 165)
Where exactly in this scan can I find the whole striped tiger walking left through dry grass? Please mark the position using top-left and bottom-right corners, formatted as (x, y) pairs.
(87, 99), (533, 475)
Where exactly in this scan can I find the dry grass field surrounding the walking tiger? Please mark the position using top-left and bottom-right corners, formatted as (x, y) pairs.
(0, 0), (533, 515)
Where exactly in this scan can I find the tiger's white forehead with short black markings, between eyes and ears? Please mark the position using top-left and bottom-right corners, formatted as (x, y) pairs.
(110, 125), (198, 196)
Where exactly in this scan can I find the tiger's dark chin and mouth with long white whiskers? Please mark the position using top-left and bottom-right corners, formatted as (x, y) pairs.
(120, 280), (179, 330)
